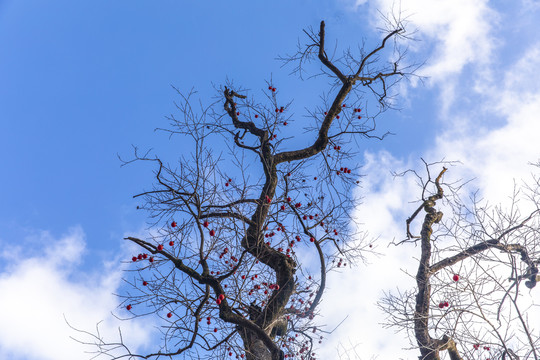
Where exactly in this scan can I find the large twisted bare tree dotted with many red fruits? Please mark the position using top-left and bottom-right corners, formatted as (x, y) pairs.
(71, 19), (414, 360)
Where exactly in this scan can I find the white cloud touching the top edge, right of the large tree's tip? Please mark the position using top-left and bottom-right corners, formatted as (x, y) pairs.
(368, 0), (499, 113)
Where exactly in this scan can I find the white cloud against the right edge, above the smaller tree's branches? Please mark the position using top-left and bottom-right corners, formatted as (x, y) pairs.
(432, 41), (540, 210)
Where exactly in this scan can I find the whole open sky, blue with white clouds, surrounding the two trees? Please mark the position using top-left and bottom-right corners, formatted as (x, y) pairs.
(0, 0), (540, 360)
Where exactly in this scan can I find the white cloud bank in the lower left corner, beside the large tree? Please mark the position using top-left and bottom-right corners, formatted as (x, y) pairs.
(0, 228), (154, 360)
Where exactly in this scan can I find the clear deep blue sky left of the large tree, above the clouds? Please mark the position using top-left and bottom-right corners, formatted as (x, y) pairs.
(0, 1), (412, 255)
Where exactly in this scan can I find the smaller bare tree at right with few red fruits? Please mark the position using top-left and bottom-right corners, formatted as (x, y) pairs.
(380, 163), (540, 360)
